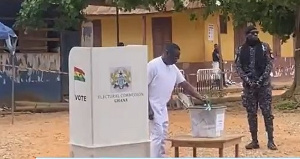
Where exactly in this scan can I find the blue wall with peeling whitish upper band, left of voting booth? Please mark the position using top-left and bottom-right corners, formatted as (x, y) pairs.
(0, 53), (61, 105)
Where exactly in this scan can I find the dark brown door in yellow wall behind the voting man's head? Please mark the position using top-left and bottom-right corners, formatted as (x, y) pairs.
(152, 17), (172, 58)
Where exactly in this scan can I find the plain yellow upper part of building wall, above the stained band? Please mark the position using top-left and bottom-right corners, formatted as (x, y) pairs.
(90, 9), (293, 63)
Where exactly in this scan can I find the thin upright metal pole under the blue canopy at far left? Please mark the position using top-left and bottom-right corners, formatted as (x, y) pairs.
(11, 51), (16, 124)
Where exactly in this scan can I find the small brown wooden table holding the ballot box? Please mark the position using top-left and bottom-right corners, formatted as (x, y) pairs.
(167, 135), (244, 157)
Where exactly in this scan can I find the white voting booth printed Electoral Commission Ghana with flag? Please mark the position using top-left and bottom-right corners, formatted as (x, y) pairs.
(69, 45), (150, 157)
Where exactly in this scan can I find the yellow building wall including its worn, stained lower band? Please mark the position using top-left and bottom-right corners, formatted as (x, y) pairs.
(88, 10), (294, 84)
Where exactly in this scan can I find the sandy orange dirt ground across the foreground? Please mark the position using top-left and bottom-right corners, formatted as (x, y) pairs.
(0, 107), (300, 159)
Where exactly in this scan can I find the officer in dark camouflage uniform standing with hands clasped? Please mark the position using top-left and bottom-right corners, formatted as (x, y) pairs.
(235, 26), (277, 150)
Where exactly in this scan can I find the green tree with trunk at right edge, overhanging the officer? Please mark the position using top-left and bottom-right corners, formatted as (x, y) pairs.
(195, 0), (300, 103)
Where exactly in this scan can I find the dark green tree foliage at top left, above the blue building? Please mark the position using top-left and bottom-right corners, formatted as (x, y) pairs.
(15, 0), (87, 30)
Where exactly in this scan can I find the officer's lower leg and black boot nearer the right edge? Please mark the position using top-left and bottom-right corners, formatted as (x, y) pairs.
(264, 115), (278, 150)
